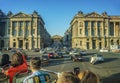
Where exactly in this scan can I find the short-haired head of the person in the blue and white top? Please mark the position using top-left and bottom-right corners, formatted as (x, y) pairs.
(30, 57), (41, 71)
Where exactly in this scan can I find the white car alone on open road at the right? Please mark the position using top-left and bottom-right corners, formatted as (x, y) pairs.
(90, 54), (104, 65)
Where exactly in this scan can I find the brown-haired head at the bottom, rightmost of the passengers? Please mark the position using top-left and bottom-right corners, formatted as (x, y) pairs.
(78, 70), (100, 83)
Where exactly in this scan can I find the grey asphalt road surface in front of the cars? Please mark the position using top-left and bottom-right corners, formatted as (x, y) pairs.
(43, 53), (120, 82)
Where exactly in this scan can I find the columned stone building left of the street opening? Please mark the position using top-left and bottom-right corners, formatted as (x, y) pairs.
(1, 11), (51, 49)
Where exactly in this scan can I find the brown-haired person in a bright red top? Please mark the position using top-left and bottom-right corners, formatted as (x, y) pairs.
(4, 53), (28, 83)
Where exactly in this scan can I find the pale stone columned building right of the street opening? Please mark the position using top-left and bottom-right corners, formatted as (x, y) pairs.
(66, 11), (120, 50)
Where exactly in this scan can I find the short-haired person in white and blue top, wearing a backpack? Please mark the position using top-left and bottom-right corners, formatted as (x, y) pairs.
(23, 57), (46, 83)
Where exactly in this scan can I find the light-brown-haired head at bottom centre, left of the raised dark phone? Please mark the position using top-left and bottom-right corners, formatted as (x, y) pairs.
(57, 72), (80, 83)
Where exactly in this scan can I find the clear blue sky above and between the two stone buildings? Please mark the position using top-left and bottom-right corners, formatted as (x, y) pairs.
(0, 0), (120, 36)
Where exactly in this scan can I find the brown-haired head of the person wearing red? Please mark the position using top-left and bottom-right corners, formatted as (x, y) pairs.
(11, 53), (23, 67)
